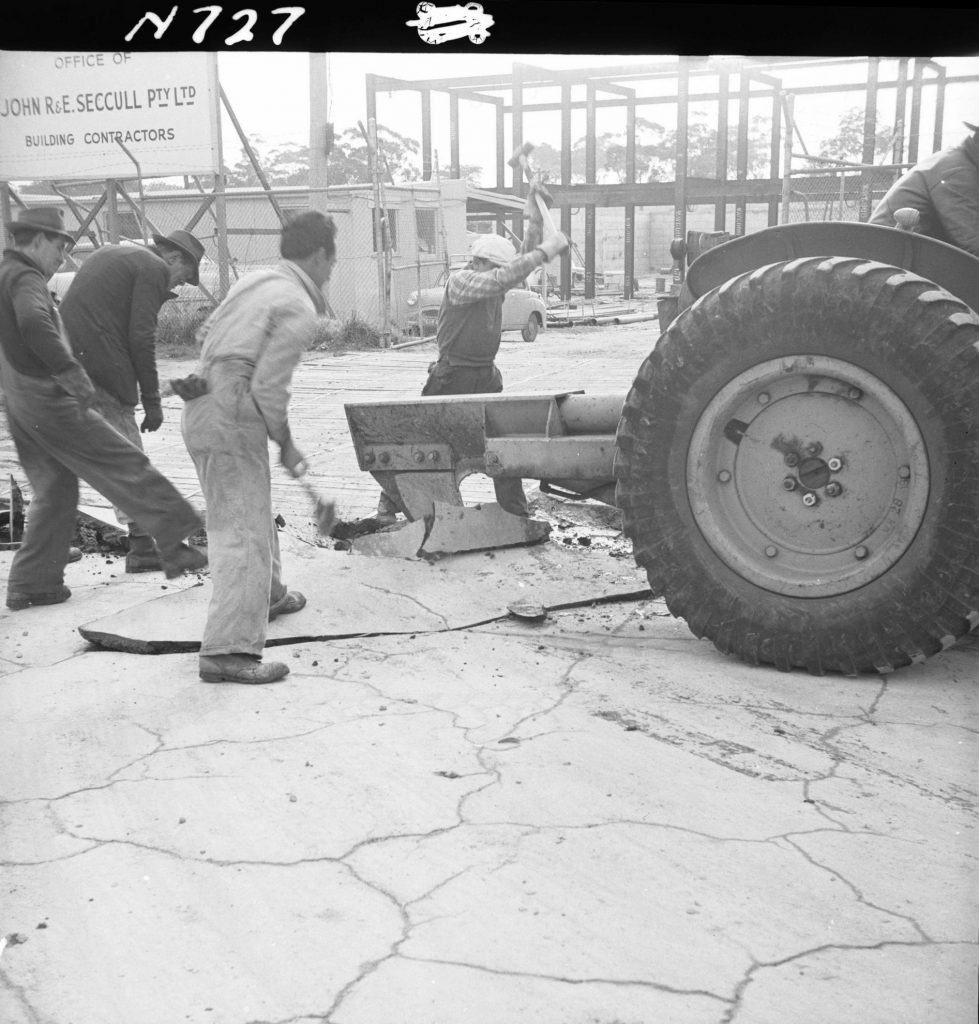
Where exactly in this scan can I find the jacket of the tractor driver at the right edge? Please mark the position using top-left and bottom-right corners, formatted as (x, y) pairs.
(869, 132), (979, 256)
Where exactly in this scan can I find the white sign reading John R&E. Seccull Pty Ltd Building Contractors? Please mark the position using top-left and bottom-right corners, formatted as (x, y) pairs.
(0, 50), (220, 181)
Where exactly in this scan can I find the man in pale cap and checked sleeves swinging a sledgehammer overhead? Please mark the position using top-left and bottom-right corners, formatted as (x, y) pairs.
(376, 184), (568, 525)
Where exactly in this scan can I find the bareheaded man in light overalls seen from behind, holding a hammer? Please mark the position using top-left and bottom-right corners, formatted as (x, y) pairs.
(173, 211), (336, 683)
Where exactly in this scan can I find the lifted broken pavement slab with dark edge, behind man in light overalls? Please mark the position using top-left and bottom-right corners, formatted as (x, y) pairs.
(79, 538), (649, 654)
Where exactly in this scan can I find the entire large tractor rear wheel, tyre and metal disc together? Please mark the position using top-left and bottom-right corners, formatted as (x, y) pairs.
(615, 257), (979, 674)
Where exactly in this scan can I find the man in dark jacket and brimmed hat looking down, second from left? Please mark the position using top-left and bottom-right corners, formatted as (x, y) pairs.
(60, 230), (204, 572)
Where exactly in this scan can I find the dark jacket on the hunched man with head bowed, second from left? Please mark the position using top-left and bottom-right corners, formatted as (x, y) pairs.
(61, 246), (173, 406)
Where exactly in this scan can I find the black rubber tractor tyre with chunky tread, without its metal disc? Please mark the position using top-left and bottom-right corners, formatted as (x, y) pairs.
(614, 257), (979, 675)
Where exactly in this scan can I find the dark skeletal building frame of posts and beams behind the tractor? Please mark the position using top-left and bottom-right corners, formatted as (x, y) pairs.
(367, 56), (979, 299)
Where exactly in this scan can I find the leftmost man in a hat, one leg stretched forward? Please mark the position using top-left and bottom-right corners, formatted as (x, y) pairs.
(0, 206), (207, 611)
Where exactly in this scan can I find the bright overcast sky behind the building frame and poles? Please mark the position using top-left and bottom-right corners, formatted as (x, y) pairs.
(218, 50), (979, 181)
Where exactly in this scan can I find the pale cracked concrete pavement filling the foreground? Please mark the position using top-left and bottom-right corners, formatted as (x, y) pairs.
(0, 332), (979, 1024)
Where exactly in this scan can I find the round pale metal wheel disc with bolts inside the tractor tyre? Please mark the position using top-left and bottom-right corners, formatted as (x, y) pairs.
(687, 355), (929, 597)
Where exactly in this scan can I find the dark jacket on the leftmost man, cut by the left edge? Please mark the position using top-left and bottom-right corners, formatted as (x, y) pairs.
(0, 249), (80, 377)
